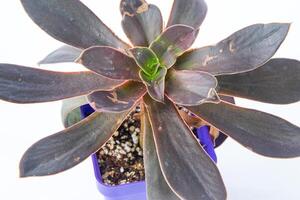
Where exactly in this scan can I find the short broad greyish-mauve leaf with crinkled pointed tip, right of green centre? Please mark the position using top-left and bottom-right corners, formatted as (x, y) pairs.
(166, 69), (220, 106)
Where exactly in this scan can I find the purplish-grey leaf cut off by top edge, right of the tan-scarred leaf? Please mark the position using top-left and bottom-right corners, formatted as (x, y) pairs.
(167, 0), (207, 29)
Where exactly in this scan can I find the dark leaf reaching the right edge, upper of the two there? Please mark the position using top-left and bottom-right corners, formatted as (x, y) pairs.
(217, 58), (300, 104)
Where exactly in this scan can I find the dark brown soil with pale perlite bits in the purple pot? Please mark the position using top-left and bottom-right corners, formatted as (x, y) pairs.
(97, 107), (145, 186)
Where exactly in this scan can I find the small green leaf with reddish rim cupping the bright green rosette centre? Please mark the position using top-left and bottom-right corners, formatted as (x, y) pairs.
(128, 47), (160, 76)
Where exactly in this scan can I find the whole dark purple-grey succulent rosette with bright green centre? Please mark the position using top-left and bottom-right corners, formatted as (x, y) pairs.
(0, 0), (300, 200)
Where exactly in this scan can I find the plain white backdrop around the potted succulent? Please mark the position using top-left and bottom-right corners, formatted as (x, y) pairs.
(0, 0), (300, 200)
